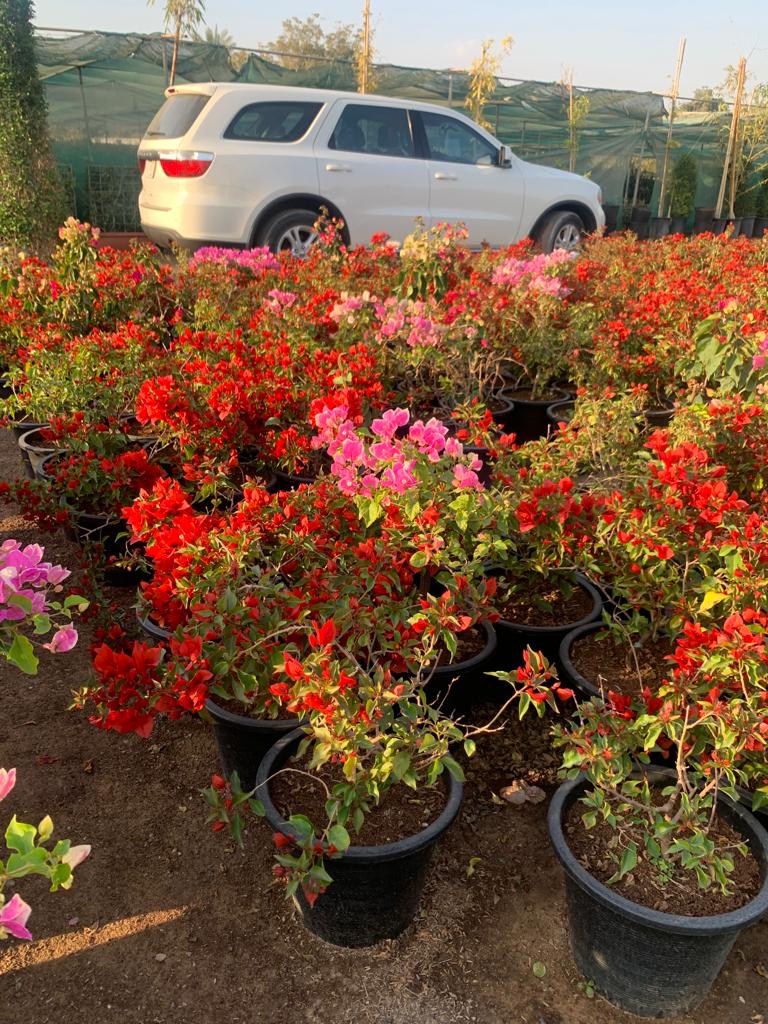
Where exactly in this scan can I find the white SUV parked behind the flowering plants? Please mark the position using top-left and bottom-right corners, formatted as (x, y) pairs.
(138, 83), (605, 255)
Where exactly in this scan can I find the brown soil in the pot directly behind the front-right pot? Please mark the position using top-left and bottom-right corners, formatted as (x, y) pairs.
(570, 631), (675, 696)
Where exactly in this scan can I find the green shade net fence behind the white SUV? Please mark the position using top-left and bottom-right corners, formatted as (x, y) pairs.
(37, 32), (728, 230)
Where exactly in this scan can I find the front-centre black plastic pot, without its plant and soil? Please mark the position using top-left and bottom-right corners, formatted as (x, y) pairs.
(257, 729), (463, 948)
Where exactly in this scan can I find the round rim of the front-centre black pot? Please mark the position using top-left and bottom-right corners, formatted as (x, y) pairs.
(256, 729), (464, 864)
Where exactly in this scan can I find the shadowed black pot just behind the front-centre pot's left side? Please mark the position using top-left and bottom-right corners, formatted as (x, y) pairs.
(206, 697), (303, 790)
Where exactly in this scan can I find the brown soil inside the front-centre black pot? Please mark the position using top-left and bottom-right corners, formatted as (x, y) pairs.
(269, 758), (445, 846)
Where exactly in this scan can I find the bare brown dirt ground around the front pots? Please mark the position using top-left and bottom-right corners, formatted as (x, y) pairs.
(0, 435), (768, 1024)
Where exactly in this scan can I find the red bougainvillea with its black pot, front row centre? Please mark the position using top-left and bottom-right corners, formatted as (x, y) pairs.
(205, 624), (569, 946)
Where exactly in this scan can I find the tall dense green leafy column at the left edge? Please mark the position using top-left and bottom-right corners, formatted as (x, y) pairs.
(0, 0), (66, 249)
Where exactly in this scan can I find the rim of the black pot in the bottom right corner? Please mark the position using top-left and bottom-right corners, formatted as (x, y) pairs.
(547, 768), (768, 936)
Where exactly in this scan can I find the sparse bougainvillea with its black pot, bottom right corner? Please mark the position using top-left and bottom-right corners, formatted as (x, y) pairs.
(493, 631), (768, 1017)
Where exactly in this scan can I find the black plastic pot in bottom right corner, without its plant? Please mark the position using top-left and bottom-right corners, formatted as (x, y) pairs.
(548, 772), (768, 1018)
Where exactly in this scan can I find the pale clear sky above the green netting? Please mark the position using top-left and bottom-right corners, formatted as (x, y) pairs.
(35, 0), (768, 96)
